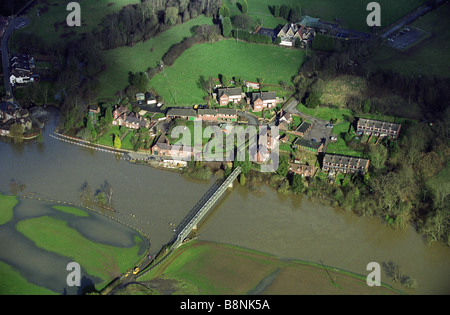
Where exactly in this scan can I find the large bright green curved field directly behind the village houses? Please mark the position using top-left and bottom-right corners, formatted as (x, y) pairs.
(150, 39), (305, 106)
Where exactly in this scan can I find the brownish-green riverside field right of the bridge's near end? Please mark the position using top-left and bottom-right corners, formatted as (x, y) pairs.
(135, 241), (398, 295)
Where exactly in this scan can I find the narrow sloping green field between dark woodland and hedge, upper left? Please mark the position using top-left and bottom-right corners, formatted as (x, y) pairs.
(98, 15), (212, 99)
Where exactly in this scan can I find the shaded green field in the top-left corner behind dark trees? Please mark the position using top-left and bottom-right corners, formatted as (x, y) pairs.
(14, 0), (141, 45)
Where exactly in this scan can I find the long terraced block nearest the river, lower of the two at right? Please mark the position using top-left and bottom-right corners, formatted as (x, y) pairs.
(322, 154), (370, 174)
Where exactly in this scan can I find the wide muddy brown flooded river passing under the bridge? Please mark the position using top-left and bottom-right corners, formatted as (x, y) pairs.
(0, 109), (450, 294)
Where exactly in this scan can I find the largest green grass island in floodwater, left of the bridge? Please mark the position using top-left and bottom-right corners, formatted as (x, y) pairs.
(16, 216), (142, 281)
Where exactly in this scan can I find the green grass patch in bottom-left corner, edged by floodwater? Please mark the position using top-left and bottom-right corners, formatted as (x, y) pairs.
(0, 261), (58, 295)
